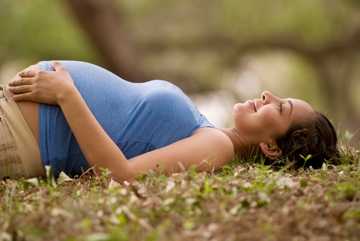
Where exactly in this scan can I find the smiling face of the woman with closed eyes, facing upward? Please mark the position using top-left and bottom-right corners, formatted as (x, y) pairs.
(233, 91), (314, 144)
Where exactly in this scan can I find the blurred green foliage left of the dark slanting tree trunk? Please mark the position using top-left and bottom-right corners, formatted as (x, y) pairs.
(0, 0), (96, 64)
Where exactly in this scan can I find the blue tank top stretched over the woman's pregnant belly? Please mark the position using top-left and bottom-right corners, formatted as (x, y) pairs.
(38, 61), (215, 176)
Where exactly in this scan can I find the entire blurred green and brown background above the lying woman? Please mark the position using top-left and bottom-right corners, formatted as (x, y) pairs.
(0, 0), (360, 143)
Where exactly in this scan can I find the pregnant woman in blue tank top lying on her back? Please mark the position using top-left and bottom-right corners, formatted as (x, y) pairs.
(0, 61), (338, 181)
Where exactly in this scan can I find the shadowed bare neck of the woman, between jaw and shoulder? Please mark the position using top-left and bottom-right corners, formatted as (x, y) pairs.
(220, 127), (258, 158)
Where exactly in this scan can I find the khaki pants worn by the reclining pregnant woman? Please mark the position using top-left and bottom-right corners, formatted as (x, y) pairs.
(0, 85), (45, 180)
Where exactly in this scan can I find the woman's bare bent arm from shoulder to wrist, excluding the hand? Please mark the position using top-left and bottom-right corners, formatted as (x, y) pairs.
(59, 88), (232, 181)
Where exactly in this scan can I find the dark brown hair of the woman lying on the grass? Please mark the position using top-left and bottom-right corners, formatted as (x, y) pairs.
(265, 112), (339, 168)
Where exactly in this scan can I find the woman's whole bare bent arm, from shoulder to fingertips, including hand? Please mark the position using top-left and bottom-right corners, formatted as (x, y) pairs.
(10, 62), (232, 181)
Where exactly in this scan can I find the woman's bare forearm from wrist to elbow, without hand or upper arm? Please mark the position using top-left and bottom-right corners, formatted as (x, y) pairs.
(58, 84), (133, 180)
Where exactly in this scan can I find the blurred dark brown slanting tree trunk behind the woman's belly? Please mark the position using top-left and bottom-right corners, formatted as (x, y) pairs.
(64, 0), (145, 82)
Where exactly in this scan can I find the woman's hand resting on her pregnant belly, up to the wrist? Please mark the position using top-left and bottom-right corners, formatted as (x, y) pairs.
(8, 62), (76, 105)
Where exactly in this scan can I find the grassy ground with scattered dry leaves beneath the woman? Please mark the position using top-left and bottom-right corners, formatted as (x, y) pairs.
(0, 145), (360, 241)
